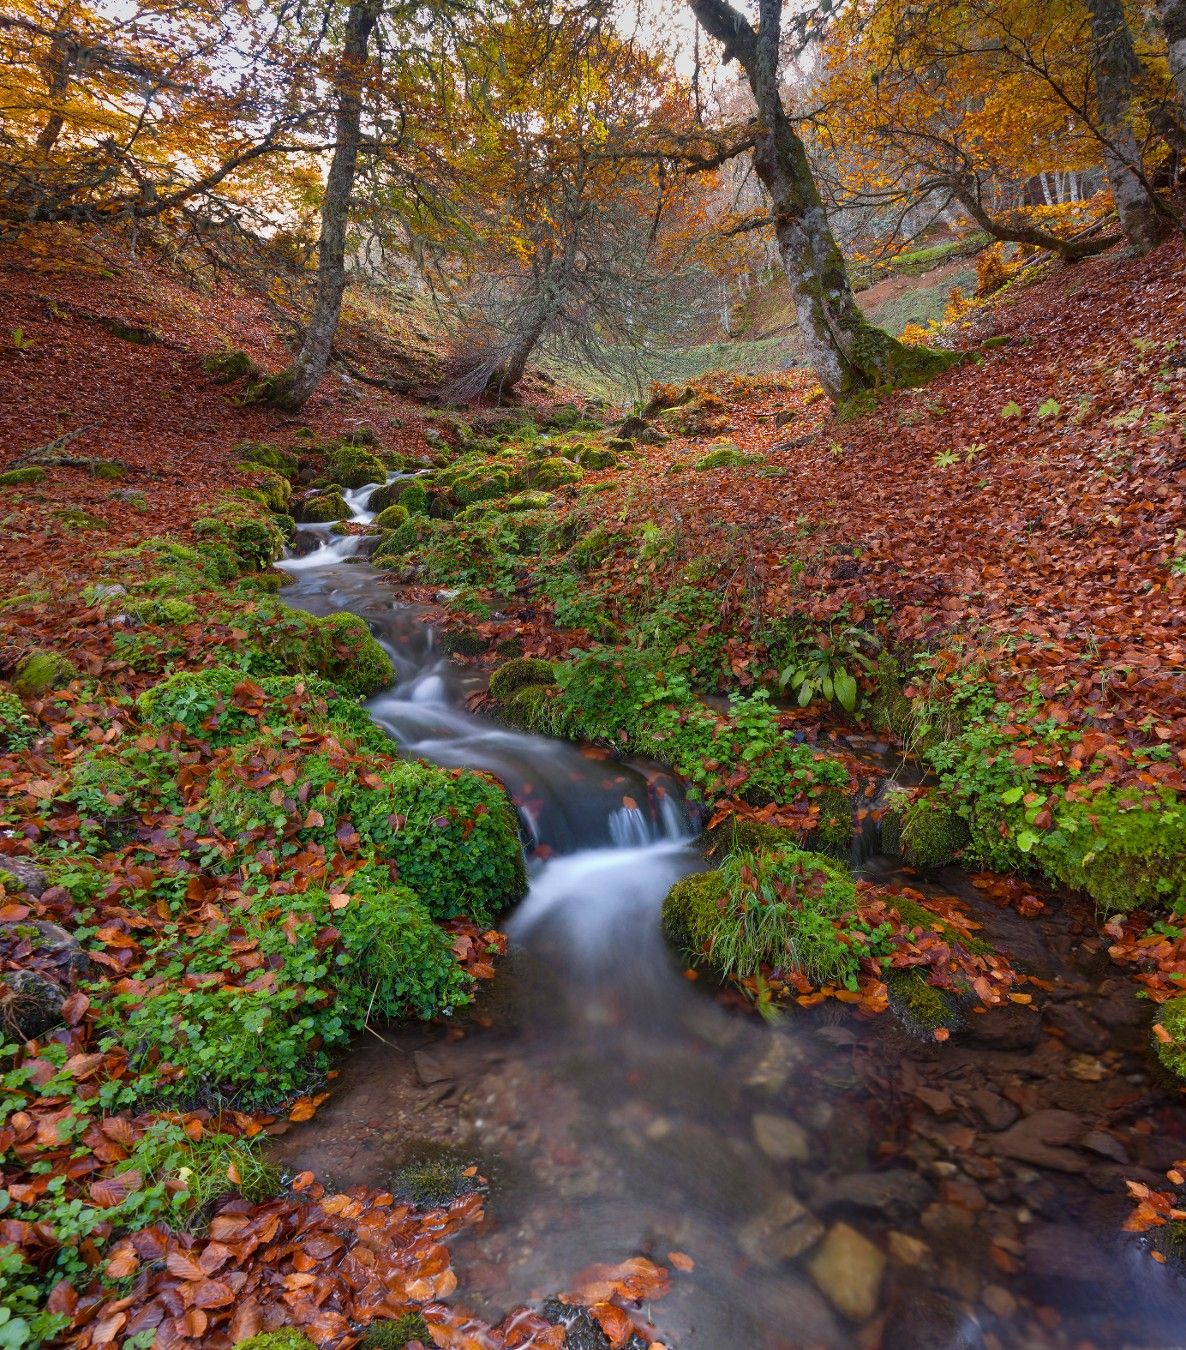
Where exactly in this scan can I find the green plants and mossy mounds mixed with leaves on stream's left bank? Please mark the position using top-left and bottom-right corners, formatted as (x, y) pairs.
(0, 477), (526, 1328)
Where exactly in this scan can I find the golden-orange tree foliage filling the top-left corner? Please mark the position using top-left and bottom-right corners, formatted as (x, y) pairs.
(0, 0), (312, 230)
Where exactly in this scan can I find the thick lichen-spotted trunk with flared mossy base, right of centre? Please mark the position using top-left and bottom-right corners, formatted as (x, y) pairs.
(688, 0), (957, 401)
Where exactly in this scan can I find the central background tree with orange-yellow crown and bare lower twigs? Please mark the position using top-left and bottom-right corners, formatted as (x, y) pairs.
(434, 12), (707, 400)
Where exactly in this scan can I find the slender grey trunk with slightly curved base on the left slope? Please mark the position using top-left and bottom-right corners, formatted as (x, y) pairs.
(267, 0), (382, 412)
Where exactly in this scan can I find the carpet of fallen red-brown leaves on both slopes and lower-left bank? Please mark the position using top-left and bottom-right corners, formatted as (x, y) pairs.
(0, 221), (1186, 1347)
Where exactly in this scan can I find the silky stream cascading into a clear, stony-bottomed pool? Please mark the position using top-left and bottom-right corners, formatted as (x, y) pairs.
(279, 489), (1186, 1350)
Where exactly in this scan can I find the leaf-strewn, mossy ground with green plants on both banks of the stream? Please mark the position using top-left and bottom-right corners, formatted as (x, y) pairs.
(0, 225), (1186, 1350)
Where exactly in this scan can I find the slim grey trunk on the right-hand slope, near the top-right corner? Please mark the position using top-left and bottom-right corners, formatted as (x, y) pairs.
(1088, 0), (1166, 250)
